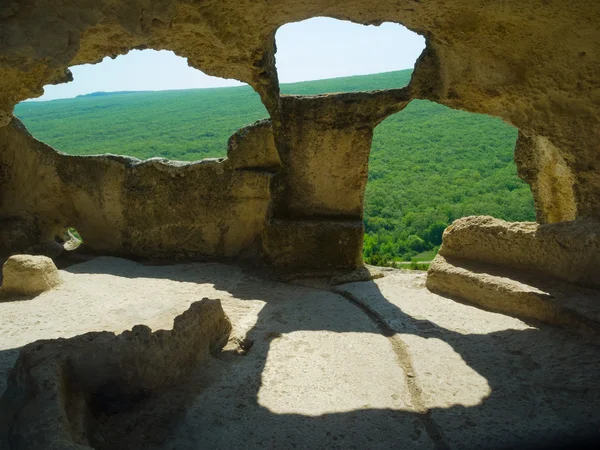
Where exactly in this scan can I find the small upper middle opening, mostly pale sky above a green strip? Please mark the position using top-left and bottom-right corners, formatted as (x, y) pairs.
(275, 17), (425, 95)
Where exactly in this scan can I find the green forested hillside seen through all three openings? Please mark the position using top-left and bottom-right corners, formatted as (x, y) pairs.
(15, 70), (535, 265)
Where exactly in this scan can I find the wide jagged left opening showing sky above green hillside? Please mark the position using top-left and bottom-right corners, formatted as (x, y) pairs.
(14, 50), (268, 161)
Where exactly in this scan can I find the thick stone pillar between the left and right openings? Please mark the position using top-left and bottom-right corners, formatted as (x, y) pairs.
(262, 89), (410, 269)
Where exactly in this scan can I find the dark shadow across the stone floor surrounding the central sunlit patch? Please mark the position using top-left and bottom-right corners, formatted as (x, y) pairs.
(4, 261), (600, 450)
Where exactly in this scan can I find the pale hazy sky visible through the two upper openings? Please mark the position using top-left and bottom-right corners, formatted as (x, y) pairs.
(37, 17), (425, 100)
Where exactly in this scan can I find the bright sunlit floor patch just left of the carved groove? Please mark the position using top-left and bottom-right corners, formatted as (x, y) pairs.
(258, 331), (412, 416)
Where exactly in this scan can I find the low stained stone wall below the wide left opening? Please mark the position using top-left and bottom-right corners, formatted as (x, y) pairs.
(0, 118), (277, 259)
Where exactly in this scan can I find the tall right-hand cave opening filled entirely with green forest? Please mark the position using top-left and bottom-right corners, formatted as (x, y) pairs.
(363, 100), (535, 270)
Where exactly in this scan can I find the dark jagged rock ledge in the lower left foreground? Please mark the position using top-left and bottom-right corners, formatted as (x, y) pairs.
(0, 298), (231, 450)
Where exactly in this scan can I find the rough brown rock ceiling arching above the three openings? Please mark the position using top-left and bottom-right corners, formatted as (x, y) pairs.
(0, 0), (600, 217)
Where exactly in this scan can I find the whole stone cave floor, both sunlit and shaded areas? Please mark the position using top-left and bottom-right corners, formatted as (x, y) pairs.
(0, 257), (600, 450)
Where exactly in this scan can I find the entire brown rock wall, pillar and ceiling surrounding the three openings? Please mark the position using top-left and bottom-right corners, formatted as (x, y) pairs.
(0, 0), (600, 267)
